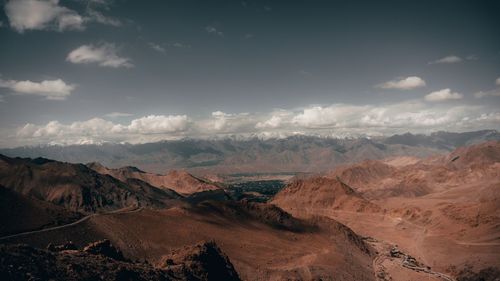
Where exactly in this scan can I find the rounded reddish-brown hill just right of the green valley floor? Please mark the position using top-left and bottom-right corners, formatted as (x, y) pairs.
(271, 177), (382, 216)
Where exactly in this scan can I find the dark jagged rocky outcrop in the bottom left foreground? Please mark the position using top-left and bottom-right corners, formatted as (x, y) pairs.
(0, 240), (240, 280)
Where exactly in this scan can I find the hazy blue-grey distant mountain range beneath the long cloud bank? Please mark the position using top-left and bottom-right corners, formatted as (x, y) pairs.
(0, 130), (500, 174)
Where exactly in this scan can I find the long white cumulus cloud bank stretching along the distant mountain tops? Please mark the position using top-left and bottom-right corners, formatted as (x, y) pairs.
(7, 100), (500, 145)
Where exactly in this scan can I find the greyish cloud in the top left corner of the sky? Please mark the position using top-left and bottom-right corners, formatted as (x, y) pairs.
(5, 0), (84, 32)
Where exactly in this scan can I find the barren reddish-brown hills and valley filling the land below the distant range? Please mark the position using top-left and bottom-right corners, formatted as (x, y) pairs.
(0, 135), (500, 281)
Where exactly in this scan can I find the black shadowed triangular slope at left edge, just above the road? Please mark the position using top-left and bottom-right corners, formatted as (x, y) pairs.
(0, 185), (82, 236)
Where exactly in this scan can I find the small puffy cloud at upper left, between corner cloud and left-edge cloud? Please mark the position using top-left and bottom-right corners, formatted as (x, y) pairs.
(66, 43), (134, 68)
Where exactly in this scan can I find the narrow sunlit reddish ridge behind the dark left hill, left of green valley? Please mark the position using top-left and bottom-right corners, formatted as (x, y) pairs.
(87, 163), (220, 195)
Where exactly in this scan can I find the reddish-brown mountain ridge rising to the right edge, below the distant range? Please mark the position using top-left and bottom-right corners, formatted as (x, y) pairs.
(327, 141), (500, 199)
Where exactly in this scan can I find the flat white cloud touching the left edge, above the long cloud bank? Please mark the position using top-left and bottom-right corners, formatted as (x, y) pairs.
(0, 79), (76, 100)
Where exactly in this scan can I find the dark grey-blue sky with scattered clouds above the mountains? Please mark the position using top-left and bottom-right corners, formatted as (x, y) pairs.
(0, 0), (500, 147)
